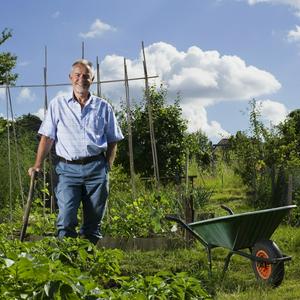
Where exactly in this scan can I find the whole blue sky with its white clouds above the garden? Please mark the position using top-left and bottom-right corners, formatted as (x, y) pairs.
(0, 0), (300, 141)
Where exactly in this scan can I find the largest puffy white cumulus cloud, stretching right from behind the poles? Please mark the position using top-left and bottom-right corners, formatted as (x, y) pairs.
(101, 42), (281, 106)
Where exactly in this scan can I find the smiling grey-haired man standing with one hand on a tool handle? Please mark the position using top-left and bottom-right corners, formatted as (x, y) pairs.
(28, 60), (123, 244)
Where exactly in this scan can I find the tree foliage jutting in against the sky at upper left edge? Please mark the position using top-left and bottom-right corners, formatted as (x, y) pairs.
(0, 28), (18, 85)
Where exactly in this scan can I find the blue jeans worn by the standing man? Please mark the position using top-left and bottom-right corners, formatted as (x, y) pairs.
(56, 156), (108, 244)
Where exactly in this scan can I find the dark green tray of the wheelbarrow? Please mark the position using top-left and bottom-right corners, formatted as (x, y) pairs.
(188, 205), (296, 251)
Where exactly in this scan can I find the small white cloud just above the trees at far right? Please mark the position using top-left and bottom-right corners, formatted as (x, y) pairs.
(257, 100), (289, 125)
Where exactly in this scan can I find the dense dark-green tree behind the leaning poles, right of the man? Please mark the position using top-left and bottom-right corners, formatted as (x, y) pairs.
(117, 87), (187, 177)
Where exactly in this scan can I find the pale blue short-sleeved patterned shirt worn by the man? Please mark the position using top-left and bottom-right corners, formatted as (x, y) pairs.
(39, 95), (124, 160)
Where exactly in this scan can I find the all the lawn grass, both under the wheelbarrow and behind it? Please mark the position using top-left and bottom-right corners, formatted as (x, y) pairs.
(118, 163), (300, 300)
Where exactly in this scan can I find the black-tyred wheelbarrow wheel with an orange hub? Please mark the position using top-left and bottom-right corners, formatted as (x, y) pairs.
(252, 240), (284, 287)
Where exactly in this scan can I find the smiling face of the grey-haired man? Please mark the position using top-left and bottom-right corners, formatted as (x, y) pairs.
(70, 65), (93, 94)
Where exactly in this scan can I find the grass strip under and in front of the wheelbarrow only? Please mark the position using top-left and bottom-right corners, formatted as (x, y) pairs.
(121, 225), (300, 300)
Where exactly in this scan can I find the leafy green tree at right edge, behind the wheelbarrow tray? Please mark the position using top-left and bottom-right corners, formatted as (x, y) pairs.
(230, 100), (300, 211)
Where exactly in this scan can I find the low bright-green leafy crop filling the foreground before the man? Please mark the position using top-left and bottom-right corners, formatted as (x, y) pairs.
(0, 233), (209, 300)
